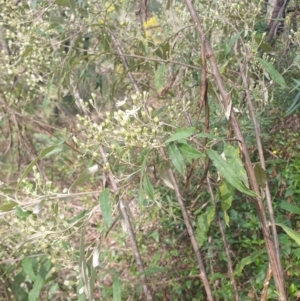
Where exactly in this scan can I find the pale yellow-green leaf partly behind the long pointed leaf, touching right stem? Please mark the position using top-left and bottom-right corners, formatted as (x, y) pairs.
(224, 143), (249, 188)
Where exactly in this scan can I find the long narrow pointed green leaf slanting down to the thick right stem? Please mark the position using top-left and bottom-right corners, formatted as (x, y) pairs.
(207, 149), (256, 196)
